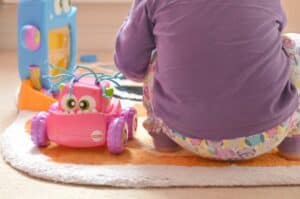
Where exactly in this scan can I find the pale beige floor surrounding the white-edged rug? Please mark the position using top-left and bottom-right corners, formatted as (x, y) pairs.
(0, 51), (300, 199)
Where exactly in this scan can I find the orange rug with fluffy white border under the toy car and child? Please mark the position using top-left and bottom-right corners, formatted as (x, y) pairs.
(1, 104), (300, 188)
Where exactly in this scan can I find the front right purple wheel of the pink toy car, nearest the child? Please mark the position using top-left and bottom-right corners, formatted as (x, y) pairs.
(107, 117), (128, 154)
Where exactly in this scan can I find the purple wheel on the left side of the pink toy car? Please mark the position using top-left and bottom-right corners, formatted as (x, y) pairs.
(31, 112), (49, 147)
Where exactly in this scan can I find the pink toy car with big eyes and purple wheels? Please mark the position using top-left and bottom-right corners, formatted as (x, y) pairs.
(31, 79), (137, 154)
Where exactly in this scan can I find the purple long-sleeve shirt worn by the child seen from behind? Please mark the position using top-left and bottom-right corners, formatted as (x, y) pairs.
(115, 0), (298, 140)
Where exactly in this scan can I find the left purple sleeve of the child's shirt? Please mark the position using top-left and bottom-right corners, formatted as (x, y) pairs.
(114, 0), (155, 81)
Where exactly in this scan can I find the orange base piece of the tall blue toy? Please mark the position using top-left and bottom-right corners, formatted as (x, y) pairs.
(17, 80), (56, 111)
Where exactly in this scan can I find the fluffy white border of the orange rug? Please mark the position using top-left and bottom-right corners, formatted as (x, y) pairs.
(0, 112), (300, 188)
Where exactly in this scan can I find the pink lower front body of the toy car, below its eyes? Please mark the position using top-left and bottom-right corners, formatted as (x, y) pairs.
(47, 100), (121, 148)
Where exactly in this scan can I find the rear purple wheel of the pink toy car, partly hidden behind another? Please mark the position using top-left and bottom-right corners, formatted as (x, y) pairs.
(121, 107), (138, 140)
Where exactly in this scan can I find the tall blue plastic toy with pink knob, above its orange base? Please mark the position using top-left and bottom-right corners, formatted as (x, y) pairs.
(18, 0), (77, 89)
